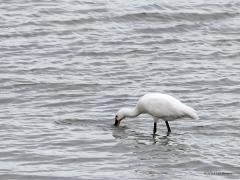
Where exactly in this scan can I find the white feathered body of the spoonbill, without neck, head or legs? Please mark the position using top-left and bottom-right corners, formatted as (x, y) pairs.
(137, 93), (197, 120)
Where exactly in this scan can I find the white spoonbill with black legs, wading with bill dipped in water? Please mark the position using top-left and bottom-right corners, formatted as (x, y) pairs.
(114, 93), (198, 135)
